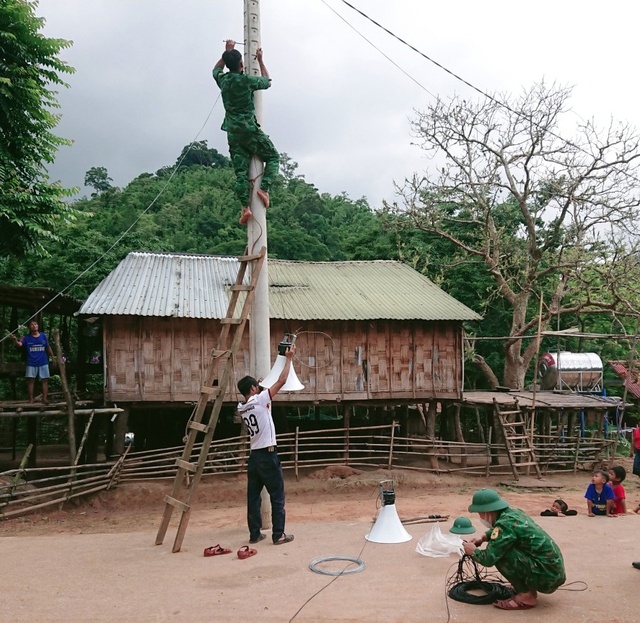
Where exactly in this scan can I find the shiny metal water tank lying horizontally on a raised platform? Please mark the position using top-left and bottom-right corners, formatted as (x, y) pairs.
(538, 351), (603, 391)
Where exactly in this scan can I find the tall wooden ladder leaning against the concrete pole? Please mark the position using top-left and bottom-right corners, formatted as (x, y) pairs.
(156, 247), (266, 553)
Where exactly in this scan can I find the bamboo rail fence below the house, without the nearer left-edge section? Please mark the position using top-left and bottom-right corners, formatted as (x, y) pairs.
(115, 425), (615, 481)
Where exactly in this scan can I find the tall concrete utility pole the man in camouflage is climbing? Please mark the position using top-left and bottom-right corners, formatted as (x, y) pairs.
(244, 0), (271, 528)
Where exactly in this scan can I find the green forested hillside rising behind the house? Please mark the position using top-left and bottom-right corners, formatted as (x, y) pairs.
(0, 141), (628, 387)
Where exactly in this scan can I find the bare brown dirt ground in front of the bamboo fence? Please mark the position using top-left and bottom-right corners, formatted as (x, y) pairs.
(0, 465), (640, 623)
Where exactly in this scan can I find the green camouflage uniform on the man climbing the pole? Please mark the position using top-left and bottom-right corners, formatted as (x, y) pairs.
(213, 67), (280, 206)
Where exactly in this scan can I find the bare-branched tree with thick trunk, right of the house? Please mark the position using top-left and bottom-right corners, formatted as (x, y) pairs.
(387, 84), (640, 389)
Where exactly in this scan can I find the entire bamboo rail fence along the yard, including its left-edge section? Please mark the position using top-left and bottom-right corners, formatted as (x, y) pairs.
(0, 425), (616, 520)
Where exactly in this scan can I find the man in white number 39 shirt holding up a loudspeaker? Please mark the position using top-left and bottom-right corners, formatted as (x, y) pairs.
(238, 344), (295, 545)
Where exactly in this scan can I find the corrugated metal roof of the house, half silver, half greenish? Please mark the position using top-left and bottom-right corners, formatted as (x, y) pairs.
(79, 252), (480, 321)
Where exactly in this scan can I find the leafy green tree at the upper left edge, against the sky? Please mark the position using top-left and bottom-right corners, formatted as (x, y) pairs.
(0, 0), (74, 256)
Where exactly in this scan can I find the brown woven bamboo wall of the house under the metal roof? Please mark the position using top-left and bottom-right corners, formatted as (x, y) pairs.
(104, 316), (463, 404)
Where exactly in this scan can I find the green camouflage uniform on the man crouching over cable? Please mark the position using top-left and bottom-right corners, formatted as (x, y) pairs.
(473, 508), (566, 593)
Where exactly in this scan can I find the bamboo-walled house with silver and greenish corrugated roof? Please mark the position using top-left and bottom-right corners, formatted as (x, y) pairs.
(79, 252), (480, 407)
